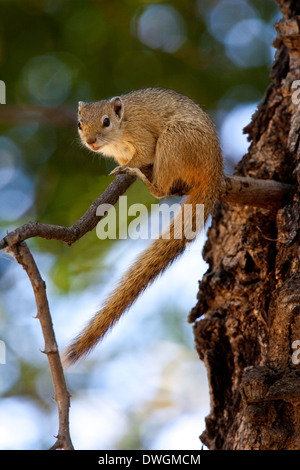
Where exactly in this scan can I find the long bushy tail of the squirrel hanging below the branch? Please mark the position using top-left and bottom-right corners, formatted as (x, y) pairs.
(65, 184), (216, 364)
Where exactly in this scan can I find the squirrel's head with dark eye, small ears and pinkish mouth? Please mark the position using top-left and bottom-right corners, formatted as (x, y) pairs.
(78, 97), (124, 153)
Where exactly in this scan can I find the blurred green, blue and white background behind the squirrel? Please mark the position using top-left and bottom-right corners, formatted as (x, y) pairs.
(0, 0), (280, 450)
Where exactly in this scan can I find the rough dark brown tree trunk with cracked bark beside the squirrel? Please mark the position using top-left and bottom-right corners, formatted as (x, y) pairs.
(190, 0), (300, 450)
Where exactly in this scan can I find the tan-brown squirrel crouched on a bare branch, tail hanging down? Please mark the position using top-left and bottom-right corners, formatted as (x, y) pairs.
(65, 88), (223, 364)
